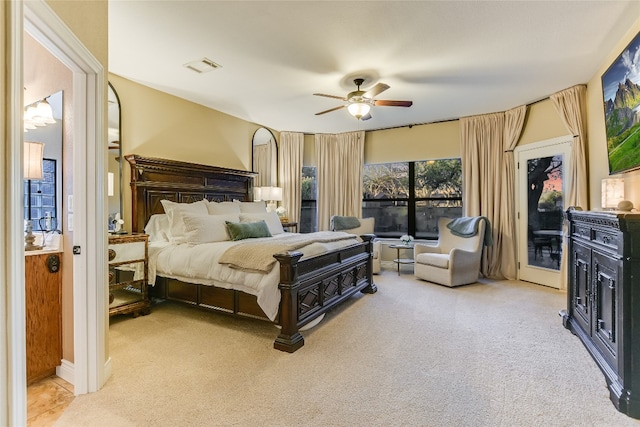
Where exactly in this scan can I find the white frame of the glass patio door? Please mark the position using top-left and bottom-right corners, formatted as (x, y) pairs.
(514, 135), (573, 289)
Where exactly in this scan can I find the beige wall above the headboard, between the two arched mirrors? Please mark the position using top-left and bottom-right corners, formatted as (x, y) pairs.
(109, 74), (262, 229)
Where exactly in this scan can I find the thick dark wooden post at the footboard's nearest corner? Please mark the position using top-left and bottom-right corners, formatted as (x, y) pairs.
(273, 251), (304, 353)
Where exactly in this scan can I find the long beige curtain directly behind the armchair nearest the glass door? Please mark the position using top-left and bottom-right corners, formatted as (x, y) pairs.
(460, 113), (505, 279)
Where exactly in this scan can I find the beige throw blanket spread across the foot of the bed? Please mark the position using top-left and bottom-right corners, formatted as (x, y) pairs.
(218, 231), (354, 273)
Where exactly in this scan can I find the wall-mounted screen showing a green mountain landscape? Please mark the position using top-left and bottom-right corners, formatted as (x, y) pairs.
(602, 33), (640, 175)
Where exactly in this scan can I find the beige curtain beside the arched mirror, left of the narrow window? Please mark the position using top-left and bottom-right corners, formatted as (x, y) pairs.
(278, 132), (304, 222)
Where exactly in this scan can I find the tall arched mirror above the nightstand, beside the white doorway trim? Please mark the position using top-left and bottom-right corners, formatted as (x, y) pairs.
(107, 83), (122, 232)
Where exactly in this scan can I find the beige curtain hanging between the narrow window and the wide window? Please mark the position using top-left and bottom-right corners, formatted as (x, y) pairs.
(315, 131), (364, 231)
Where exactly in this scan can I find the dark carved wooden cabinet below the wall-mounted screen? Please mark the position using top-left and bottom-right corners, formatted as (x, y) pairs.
(562, 210), (640, 418)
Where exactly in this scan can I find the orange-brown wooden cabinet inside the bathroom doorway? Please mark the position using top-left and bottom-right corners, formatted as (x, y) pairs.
(24, 253), (62, 384)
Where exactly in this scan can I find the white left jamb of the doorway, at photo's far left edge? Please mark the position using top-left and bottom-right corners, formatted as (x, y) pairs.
(0, 2), (27, 425)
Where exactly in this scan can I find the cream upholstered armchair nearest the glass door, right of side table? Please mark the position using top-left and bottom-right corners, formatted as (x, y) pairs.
(413, 217), (490, 287)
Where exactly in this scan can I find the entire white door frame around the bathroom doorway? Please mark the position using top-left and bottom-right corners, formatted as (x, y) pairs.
(0, 0), (110, 425)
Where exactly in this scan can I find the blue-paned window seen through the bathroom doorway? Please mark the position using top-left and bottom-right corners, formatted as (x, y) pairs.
(23, 159), (57, 231)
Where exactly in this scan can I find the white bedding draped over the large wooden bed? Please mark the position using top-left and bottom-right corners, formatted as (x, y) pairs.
(149, 233), (358, 320)
